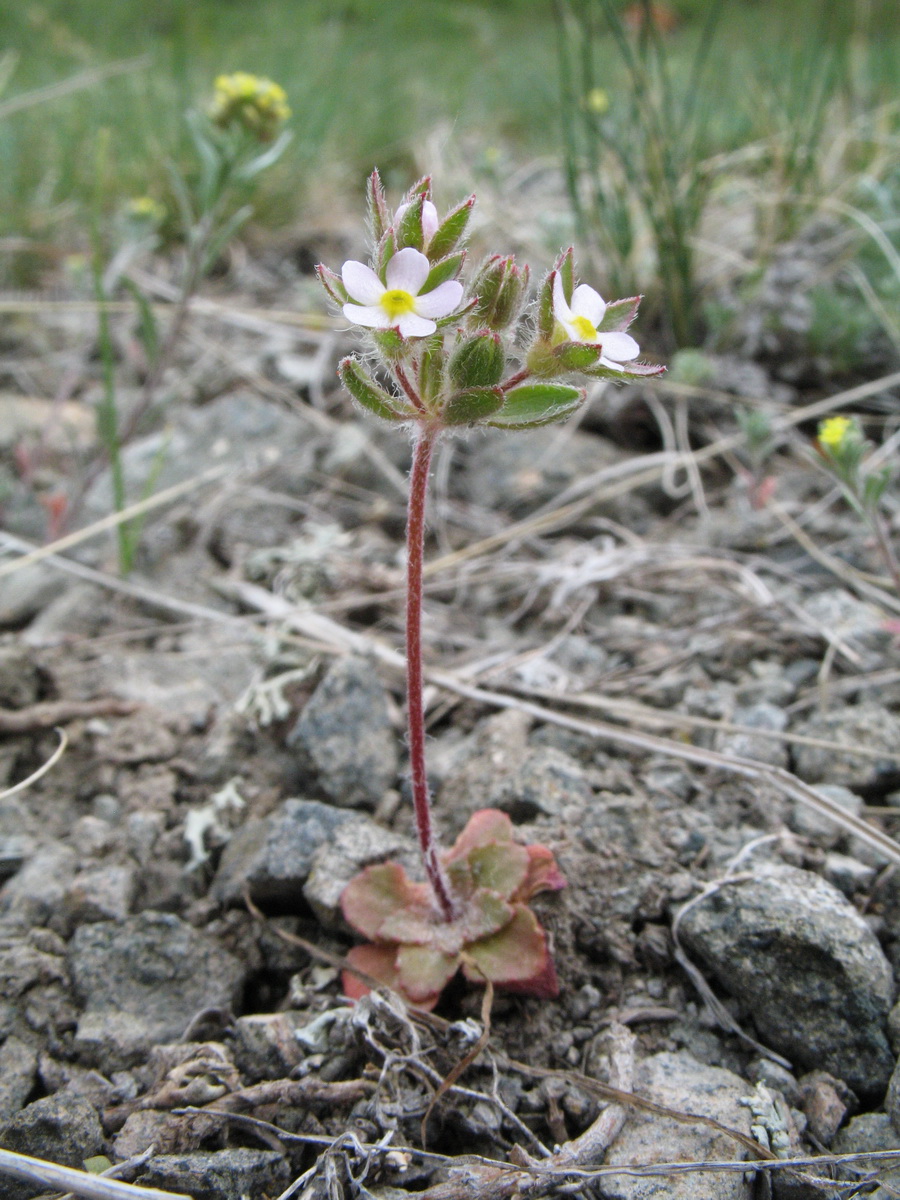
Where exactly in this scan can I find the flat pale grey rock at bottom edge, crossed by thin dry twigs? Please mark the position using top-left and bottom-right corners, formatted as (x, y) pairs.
(602, 1051), (754, 1200)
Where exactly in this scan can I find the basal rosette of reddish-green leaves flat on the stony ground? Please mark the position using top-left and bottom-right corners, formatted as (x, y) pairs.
(341, 809), (565, 1009)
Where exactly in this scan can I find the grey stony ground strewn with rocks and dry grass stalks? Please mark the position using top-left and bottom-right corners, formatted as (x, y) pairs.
(0, 218), (900, 1200)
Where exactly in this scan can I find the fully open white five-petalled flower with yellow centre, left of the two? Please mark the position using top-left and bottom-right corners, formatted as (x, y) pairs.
(341, 246), (462, 337)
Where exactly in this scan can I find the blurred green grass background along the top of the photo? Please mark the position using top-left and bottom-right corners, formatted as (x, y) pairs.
(0, 0), (900, 346)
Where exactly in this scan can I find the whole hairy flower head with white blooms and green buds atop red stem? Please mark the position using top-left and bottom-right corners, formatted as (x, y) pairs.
(318, 172), (665, 432)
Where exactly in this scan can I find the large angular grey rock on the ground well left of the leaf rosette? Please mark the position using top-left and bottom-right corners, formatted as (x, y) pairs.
(70, 912), (245, 1072)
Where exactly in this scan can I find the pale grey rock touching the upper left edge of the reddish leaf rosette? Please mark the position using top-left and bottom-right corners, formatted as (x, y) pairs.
(304, 815), (415, 932)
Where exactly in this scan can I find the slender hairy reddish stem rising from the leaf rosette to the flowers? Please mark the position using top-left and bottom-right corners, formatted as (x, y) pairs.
(407, 425), (457, 920)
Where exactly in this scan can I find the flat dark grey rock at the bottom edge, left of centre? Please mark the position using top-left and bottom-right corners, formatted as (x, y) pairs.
(136, 1150), (290, 1200)
